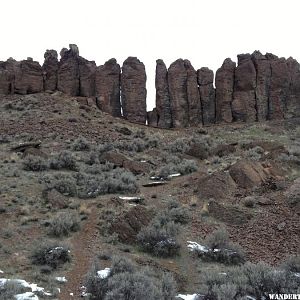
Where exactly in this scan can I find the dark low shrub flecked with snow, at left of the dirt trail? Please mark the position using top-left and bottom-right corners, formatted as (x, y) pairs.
(31, 241), (71, 269)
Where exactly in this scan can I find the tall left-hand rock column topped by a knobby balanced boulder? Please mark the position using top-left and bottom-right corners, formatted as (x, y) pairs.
(57, 45), (79, 96)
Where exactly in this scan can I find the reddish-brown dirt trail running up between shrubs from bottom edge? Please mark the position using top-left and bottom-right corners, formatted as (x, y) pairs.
(59, 209), (99, 300)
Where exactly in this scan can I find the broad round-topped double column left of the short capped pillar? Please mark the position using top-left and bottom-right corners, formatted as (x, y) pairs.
(168, 59), (202, 128)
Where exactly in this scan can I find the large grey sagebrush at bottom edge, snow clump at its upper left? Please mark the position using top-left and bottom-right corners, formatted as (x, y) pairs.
(85, 258), (176, 300)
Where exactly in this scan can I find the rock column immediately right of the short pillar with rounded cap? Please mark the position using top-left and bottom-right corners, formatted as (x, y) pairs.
(216, 58), (235, 123)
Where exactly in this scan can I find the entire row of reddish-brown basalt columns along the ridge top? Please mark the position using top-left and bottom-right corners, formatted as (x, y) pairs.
(0, 44), (300, 128)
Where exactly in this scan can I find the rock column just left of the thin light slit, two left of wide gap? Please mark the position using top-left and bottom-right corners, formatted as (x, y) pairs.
(95, 58), (121, 117)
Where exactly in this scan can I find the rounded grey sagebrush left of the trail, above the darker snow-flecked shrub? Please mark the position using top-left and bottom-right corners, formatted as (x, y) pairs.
(49, 211), (80, 237)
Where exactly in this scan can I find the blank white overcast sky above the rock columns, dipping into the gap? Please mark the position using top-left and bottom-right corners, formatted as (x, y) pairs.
(0, 0), (300, 110)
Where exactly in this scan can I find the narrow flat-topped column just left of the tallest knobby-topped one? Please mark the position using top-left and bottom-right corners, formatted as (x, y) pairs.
(43, 50), (58, 92)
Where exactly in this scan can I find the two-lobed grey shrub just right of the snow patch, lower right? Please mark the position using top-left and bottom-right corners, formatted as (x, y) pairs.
(197, 228), (245, 265)
